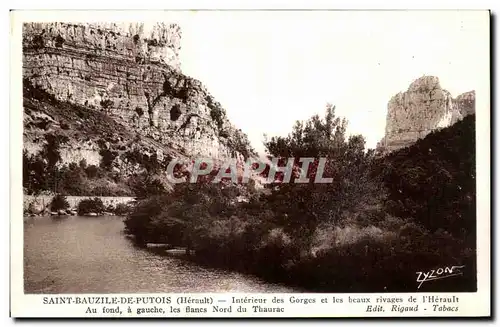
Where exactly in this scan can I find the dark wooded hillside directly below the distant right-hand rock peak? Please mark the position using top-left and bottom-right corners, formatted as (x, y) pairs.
(380, 114), (476, 243)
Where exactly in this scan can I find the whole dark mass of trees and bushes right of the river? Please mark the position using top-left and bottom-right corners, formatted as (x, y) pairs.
(125, 106), (476, 292)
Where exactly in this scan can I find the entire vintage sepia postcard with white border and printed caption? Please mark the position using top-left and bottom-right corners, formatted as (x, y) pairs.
(10, 10), (491, 318)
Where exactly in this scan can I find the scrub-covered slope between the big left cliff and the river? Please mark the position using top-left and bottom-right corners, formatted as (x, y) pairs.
(23, 79), (254, 198)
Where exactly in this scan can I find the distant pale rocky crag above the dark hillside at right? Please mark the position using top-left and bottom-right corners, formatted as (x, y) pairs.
(377, 76), (475, 153)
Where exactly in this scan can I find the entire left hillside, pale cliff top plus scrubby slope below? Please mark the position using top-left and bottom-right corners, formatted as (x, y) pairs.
(23, 23), (254, 195)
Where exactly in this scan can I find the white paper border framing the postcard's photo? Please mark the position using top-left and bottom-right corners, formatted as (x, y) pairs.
(10, 11), (491, 318)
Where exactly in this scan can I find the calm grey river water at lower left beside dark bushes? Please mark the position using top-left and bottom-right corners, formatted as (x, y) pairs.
(24, 216), (297, 293)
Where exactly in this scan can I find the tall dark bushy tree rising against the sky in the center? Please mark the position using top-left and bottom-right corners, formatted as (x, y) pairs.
(265, 105), (376, 242)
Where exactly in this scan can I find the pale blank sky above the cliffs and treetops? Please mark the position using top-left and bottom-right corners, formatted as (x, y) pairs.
(152, 11), (489, 154)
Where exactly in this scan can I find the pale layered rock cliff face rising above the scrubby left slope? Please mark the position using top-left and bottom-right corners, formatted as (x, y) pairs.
(23, 23), (254, 163)
